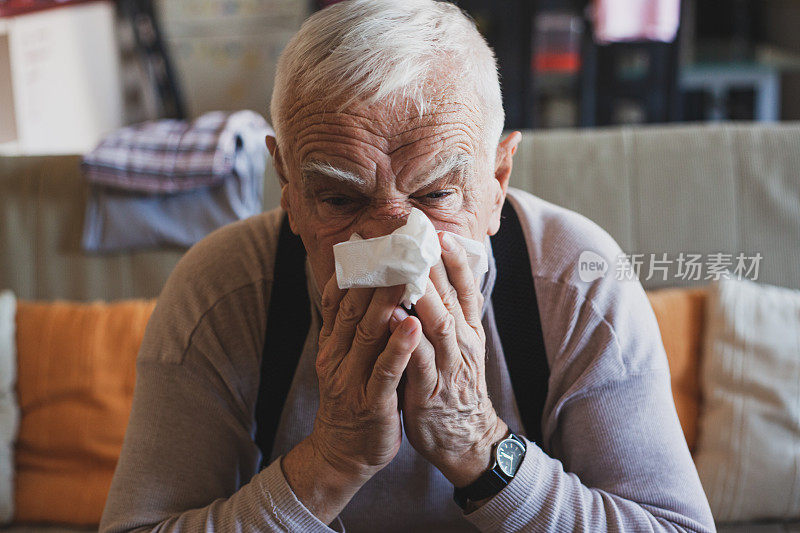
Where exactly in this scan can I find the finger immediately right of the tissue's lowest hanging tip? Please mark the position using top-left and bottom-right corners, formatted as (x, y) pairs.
(414, 280), (461, 368)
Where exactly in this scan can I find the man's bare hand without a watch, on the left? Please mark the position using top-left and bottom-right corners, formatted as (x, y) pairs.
(282, 275), (421, 523)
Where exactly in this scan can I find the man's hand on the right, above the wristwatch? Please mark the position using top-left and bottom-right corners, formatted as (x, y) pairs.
(402, 233), (508, 486)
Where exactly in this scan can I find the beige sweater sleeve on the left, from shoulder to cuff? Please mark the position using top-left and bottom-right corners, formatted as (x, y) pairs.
(100, 213), (341, 533)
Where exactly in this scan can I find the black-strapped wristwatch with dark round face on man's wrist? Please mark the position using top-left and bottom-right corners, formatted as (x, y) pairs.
(453, 431), (525, 511)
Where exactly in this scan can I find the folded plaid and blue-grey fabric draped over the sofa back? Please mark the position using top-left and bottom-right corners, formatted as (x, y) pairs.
(82, 111), (272, 252)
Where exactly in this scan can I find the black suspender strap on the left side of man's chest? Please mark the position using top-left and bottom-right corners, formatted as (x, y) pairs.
(255, 215), (311, 468)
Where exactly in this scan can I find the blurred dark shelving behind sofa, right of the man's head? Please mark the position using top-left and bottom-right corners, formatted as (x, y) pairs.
(455, 0), (800, 128)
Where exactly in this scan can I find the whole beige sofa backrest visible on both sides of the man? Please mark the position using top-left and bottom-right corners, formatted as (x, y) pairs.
(0, 123), (800, 300)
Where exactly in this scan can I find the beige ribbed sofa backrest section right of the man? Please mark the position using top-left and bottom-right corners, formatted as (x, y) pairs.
(504, 122), (800, 289)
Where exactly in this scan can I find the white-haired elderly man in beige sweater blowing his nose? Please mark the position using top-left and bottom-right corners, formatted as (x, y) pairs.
(101, 0), (714, 532)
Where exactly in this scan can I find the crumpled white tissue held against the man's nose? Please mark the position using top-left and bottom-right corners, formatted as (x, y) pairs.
(333, 208), (489, 308)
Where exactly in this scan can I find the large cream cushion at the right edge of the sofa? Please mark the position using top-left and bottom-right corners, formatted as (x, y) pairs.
(695, 280), (800, 522)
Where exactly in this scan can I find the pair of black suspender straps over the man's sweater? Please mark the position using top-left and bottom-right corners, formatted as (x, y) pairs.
(255, 201), (550, 468)
